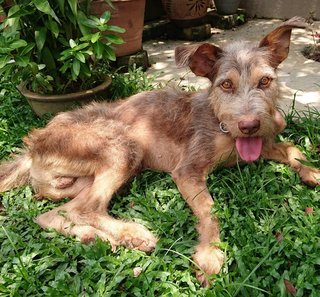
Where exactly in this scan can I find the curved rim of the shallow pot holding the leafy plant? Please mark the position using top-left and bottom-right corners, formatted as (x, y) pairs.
(17, 76), (112, 102)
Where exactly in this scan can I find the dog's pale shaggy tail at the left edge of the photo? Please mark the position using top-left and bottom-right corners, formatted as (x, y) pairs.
(0, 151), (32, 192)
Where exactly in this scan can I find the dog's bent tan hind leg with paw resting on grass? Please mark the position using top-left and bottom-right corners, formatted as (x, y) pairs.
(36, 165), (157, 251)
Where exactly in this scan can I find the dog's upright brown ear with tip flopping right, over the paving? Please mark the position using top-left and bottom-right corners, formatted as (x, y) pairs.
(259, 17), (307, 68)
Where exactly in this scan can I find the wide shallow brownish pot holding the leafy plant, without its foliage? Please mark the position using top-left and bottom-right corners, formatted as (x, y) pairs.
(18, 77), (111, 117)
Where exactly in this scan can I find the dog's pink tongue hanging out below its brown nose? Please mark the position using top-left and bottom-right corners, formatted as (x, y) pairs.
(236, 137), (262, 162)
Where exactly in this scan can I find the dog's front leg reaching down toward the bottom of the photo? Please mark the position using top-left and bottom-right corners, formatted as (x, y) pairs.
(172, 170), (223, 286)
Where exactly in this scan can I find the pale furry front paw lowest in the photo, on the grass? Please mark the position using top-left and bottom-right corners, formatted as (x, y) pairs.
(193, 245), (224, 287)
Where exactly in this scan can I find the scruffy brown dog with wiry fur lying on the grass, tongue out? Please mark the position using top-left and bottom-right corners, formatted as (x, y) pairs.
(0, 17), (320, 286)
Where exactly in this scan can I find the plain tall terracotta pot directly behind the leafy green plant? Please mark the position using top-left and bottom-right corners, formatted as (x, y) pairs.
(90, 0), (146, 57)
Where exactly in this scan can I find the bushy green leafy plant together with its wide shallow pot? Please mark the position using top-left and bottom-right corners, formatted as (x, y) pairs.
(0, 0), (125, 116)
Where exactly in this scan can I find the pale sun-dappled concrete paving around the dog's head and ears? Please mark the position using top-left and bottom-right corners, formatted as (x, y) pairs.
(143, 19), (320, 111)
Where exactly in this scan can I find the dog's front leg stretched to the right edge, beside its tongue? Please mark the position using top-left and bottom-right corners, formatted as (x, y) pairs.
(262, 143), (320, 187)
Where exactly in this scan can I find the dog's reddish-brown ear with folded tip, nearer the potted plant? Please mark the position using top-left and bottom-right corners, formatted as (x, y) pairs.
(175, 43), (222, 78)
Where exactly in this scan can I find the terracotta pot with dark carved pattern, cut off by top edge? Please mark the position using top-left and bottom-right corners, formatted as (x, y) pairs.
(162, 0), (210, 20)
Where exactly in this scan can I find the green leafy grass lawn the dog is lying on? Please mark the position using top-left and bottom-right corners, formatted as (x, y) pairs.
(0, 79), (320, 297)
